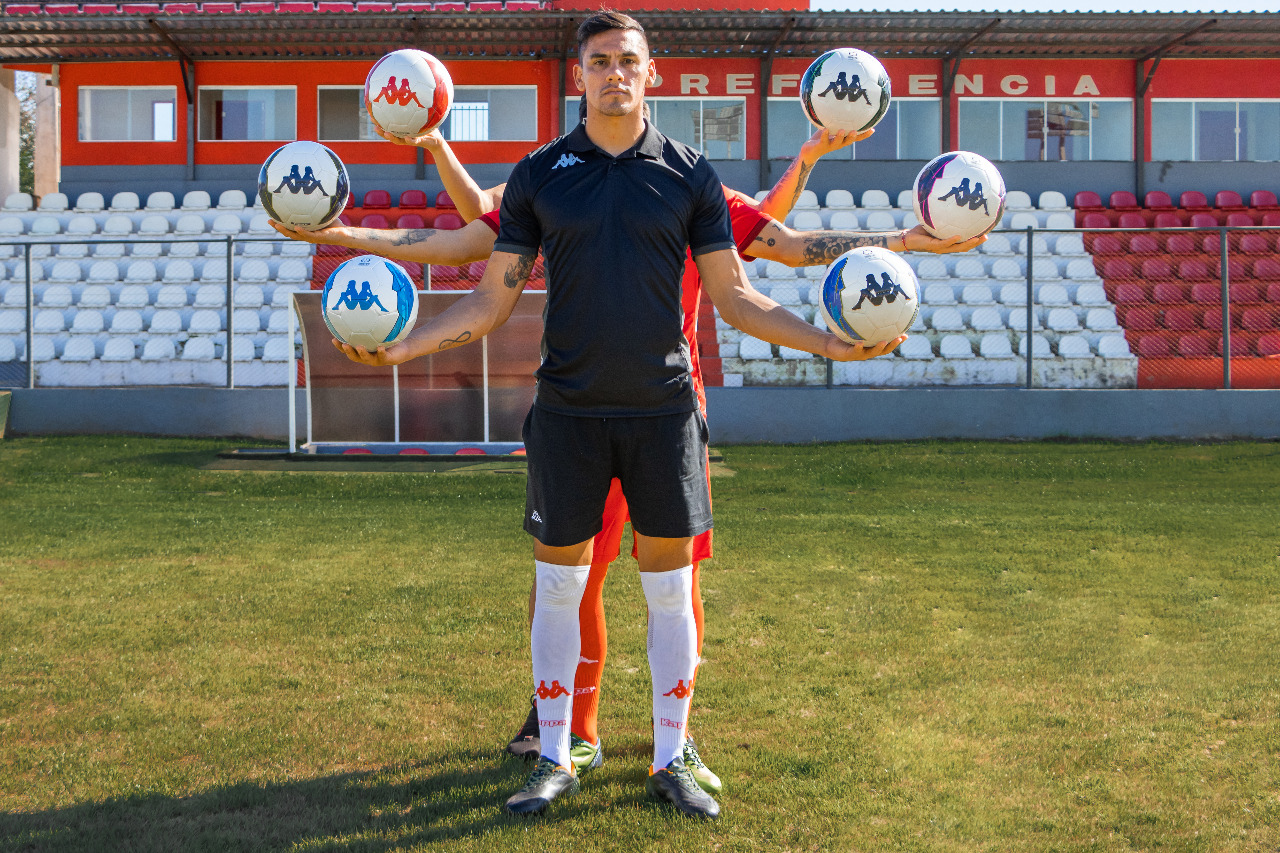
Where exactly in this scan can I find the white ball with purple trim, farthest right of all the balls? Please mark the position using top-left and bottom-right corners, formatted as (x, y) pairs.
(913, 151), (1005, 240)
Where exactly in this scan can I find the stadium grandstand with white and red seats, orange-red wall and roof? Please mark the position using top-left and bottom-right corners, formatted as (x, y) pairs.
(0, 0), (1280, 438)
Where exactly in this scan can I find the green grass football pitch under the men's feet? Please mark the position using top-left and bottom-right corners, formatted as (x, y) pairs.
(0, 437), (1280, 853)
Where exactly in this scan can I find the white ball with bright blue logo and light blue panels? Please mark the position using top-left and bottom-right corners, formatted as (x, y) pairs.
(321, 255), (417, 352)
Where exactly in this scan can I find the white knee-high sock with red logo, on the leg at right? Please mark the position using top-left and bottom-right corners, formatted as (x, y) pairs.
(640, 566), (698, 770)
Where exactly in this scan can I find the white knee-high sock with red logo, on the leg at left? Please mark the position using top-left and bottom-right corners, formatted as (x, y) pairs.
(529, 561), (591, 767)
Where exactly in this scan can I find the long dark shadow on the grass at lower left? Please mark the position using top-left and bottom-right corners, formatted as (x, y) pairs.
(0, 751), (581, 852)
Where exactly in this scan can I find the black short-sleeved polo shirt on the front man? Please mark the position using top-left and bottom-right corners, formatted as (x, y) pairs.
(494, 124), (733, 416)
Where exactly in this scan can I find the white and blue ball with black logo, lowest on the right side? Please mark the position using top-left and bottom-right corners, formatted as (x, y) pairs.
(819, 246), (920, 343)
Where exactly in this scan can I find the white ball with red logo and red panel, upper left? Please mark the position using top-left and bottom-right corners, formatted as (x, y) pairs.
(365, 47), (453, 136)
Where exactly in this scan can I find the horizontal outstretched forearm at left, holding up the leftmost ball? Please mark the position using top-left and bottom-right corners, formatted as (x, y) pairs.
(271, 222), (498, 265)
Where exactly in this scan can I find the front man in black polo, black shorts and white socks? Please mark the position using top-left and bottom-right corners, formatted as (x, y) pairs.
(342, 12), (904, 817)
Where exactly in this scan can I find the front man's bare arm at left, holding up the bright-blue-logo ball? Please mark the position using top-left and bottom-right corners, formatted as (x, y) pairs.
(333, 245), (538, 368)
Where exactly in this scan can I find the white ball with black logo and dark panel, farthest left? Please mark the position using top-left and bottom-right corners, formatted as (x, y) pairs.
(257, 141), (351, 231)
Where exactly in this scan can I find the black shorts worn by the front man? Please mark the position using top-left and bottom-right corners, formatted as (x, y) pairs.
(524, 406), (712, 548)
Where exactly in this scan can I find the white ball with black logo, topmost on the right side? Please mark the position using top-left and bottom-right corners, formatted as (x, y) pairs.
(800, 47), (891, 131)
